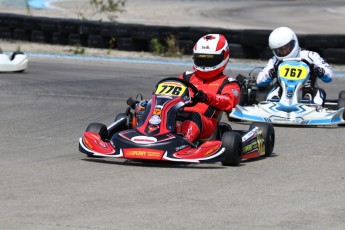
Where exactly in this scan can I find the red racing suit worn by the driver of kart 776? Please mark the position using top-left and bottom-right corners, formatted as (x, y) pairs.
(179, 72), (240, 139)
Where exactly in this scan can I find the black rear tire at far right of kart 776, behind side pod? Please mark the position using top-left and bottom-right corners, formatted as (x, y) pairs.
(249, 122), (275, 157)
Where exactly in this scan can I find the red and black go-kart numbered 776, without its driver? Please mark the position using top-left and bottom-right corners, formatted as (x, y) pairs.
(79, 78), (275, 166)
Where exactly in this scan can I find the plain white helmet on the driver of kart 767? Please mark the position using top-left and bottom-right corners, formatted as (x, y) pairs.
(268, 27), (300, 60)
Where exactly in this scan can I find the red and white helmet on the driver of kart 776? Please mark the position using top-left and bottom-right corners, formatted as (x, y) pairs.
(193, 34), (230, 79)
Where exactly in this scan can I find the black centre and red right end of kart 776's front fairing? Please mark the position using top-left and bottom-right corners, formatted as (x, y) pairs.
(108, 129), (225, 163)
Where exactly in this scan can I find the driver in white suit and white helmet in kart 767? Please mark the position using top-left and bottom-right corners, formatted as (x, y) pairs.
(256, 27), (333, 108)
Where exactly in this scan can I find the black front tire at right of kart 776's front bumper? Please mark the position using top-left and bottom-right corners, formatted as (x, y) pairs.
(222, 131), (242, 166)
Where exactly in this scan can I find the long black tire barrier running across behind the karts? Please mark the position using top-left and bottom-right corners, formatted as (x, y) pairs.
(0, 13), (345, 64)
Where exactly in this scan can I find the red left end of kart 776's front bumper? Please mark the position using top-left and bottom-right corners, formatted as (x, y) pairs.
(83, 132), (115, 155)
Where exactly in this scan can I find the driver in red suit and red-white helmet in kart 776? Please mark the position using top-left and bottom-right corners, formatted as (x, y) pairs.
(177, 34), (240, 142)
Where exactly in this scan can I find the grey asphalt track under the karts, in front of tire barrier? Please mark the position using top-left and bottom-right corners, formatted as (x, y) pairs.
(0, 57), (345, 230)
